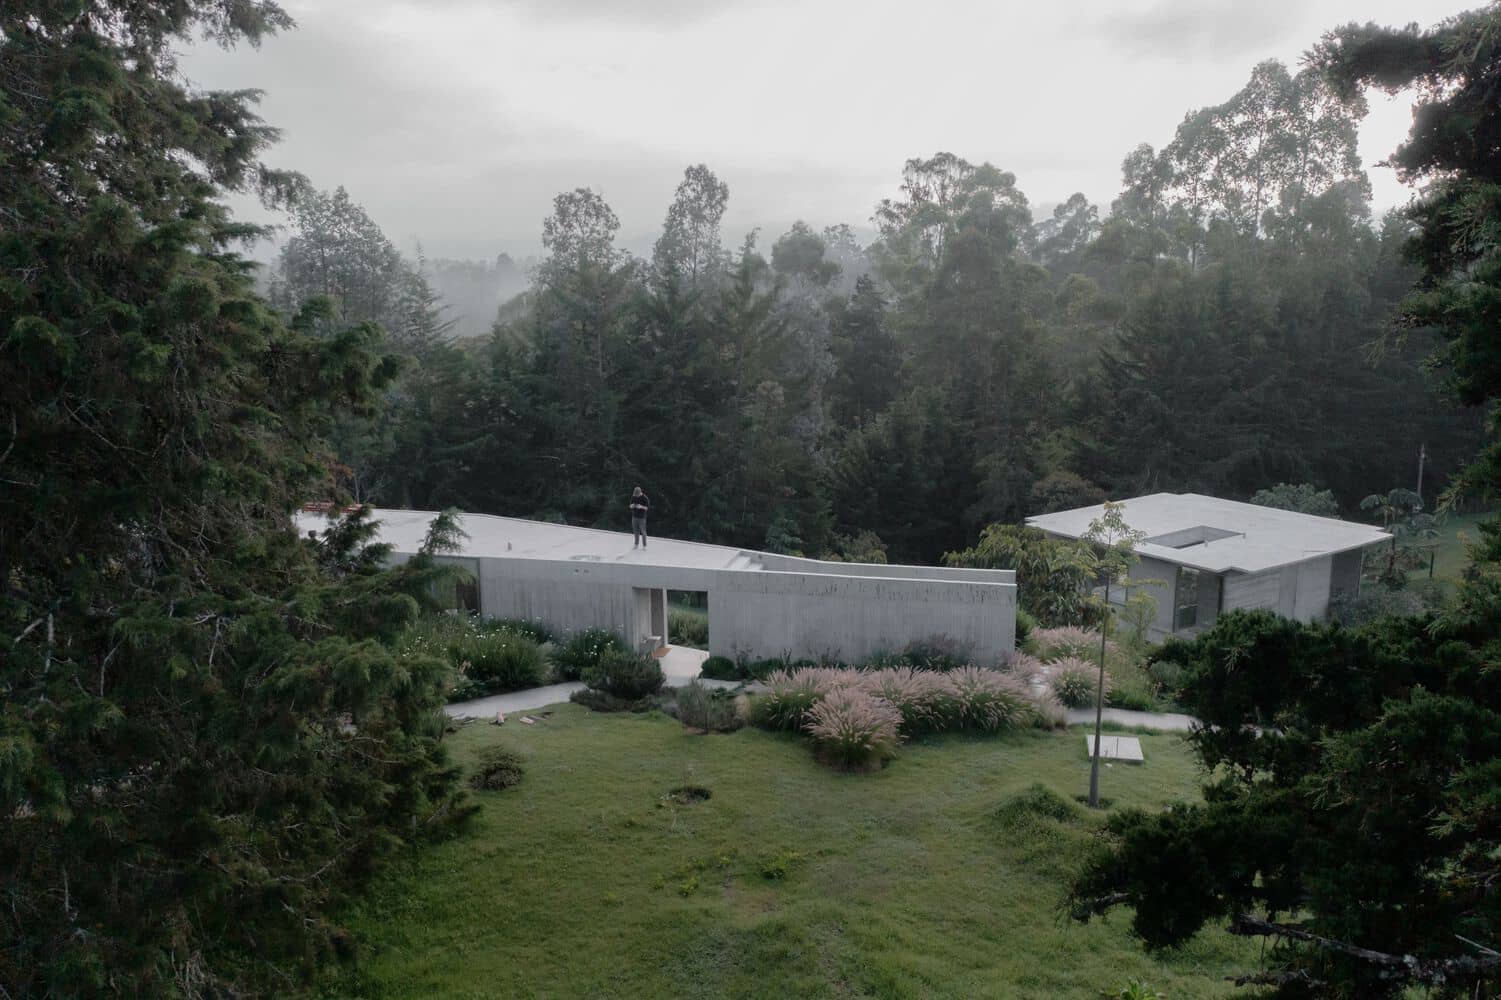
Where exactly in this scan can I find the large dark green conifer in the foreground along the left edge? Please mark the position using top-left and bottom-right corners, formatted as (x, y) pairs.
(0, 0), (459, 995)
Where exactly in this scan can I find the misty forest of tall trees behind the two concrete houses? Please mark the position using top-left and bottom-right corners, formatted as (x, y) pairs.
(273, 62), (1483, 562)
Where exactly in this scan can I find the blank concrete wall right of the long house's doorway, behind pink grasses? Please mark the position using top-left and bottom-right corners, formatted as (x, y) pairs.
(708, 571), (1016, 664)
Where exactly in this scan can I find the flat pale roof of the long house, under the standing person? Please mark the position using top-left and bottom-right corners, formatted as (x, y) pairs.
(296, 508), (755, 569)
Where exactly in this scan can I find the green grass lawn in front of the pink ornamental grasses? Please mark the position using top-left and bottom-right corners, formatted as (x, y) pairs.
(329, 706), (1258, 997)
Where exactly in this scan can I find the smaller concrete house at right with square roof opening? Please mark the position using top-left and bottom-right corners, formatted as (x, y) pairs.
(1027, 492), (1391, 640)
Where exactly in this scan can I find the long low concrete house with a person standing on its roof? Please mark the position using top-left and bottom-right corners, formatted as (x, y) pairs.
(297, 509), (1016, 664)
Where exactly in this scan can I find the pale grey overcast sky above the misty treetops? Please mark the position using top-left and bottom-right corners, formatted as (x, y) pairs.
(182, 0), (1478, 257)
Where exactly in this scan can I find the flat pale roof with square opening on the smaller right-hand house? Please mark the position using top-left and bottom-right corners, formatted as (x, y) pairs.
(1027, 492), (1391, 574)
